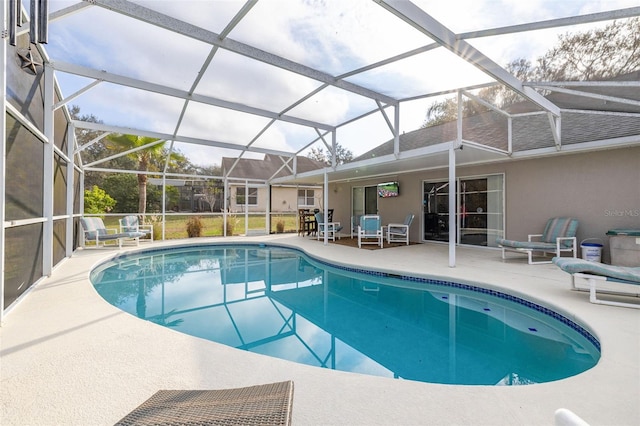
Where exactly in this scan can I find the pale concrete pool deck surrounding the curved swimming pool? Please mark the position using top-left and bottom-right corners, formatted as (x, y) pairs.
(0, 234), (640, 425)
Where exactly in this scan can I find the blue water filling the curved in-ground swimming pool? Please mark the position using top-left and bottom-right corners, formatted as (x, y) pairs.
(91, 244), (600, 385)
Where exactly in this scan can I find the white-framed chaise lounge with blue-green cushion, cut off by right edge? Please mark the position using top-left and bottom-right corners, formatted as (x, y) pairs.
(552, 257), (640, 309)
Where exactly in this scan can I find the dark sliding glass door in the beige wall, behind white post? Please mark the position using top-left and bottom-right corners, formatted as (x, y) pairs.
(422, 174), (504, 246)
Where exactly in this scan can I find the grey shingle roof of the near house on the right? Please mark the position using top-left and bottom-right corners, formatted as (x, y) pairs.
(353, 70), (640, 162)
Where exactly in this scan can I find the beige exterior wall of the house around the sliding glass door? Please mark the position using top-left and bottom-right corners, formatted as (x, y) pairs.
(329, 146), (640, 262)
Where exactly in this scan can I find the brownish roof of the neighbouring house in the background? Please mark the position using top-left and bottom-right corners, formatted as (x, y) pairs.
(222, 154), (325, 180)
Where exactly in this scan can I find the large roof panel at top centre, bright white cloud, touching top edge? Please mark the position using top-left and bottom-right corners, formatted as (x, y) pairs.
(229, 0), (431, 76)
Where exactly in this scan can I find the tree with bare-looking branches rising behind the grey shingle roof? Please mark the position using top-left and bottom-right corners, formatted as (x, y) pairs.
(422, 18), (640, 127)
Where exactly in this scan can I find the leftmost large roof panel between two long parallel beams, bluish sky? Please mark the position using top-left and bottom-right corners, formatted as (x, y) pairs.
(46, 3), (210, 90)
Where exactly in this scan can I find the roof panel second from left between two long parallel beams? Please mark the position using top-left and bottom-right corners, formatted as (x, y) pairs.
(195, 49), (321, 112)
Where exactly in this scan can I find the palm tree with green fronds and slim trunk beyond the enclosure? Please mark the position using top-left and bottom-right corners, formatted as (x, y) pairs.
(106, 135), (166, 215)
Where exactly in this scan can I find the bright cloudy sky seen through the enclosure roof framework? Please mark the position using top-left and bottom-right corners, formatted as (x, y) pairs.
(42, 0), (637, 165)
